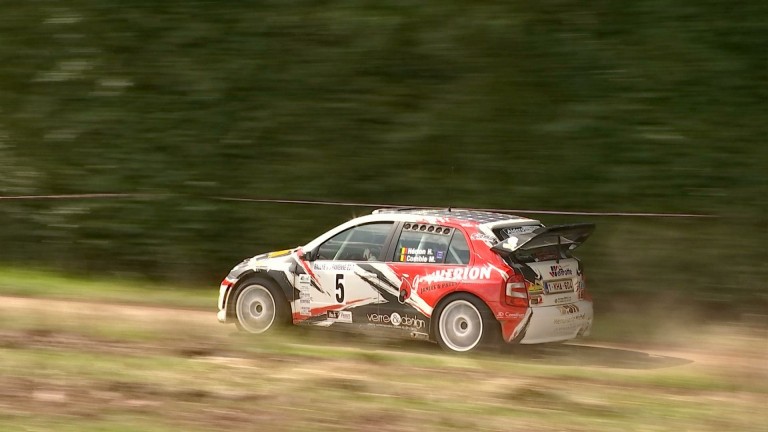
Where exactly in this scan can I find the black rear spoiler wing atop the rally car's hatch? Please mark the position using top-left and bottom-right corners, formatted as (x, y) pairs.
(491, 223), (595, 255)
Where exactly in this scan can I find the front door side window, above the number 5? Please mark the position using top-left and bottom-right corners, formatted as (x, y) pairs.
(318, 222), (393, 261)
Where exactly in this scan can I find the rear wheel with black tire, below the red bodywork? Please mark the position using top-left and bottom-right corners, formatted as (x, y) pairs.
(432, 293), (500, 353)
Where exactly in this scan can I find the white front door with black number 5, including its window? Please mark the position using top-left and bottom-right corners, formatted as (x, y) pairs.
(309, 222), (395, 325)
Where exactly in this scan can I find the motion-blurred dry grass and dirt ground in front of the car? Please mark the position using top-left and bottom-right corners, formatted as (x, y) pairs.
(0, 299), (768, 432)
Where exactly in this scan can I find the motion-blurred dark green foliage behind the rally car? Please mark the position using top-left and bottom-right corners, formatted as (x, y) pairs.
(0, 0), (768, 310)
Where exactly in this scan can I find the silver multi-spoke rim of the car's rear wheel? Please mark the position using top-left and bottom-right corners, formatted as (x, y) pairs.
(438, 300), (483, 352)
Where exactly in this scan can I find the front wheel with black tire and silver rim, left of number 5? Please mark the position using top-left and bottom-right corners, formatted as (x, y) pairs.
(232, 278), (291, 334)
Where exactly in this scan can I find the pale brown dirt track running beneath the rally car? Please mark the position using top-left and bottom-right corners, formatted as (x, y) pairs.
(0, 296), (768, 375)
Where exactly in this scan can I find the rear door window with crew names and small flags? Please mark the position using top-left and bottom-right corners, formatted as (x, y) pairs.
(392, 224), (452, 264)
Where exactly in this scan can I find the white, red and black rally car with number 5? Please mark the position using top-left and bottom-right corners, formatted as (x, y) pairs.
(218, 208), (595, 352)
